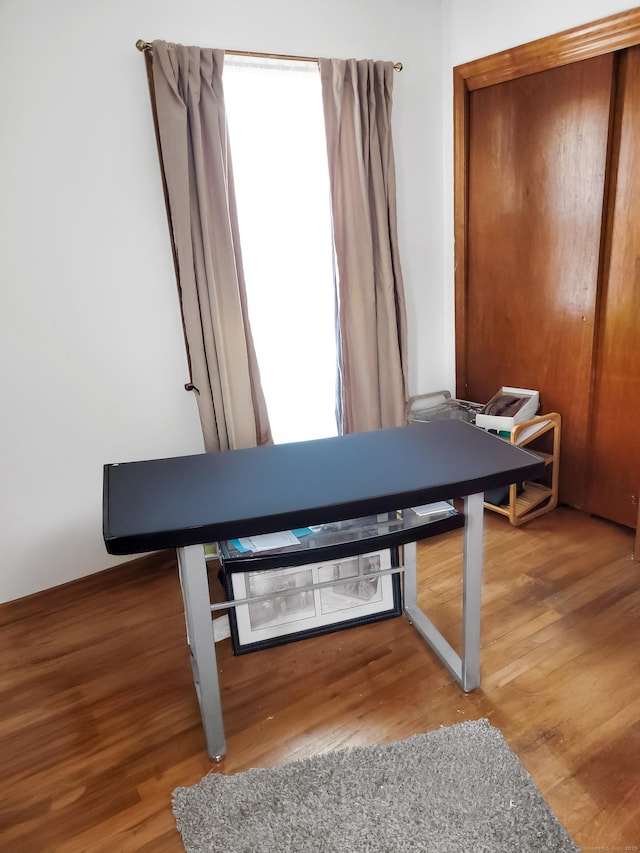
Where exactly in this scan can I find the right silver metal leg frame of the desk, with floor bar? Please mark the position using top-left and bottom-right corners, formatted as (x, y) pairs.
(404, 492), (484, 692)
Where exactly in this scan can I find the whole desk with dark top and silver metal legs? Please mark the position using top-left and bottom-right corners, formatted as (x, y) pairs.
(103, 421), (544, 760)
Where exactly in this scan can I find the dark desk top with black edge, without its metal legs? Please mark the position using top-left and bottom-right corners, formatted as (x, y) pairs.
(103, 421), (544, 554)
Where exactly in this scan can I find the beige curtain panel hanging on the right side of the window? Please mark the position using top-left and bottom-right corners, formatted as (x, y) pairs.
(320, 59), (407, 432)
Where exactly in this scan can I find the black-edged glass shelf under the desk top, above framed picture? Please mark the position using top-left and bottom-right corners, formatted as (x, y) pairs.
(218, 504), (464, 572)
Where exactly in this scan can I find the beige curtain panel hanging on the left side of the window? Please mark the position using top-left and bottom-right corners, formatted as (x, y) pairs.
(152, 41), (271, 451)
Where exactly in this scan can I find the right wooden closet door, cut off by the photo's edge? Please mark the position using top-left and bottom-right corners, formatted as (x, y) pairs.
(585, 47), (640, 527)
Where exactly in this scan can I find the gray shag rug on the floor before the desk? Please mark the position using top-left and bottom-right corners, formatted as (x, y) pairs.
(173, 720), (580, 853)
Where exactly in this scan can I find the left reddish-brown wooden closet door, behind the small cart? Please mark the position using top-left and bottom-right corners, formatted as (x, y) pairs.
(458, 55), (613, 506)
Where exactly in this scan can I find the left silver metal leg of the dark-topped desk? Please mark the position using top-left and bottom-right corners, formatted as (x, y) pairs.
(177, 545), (227, 761)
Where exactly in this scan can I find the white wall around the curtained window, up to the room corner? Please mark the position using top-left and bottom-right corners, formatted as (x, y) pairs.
(0, 0), (442, 601)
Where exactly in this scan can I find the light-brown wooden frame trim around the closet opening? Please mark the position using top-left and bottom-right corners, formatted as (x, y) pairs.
(453, 8), (640, 398)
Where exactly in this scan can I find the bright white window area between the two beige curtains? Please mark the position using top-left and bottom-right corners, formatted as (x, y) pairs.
(223, 56), (337, 443)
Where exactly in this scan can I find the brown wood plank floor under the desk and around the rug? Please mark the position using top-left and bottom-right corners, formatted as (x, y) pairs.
(0, 508), (640, 853)
